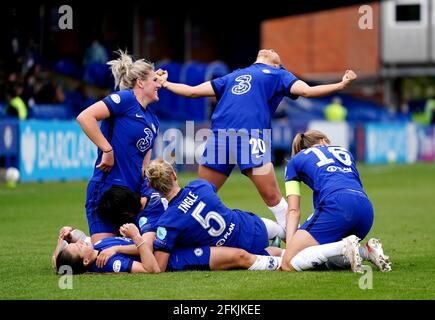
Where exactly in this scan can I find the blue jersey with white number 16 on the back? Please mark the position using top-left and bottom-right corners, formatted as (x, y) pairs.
(285, 146), (364, 208)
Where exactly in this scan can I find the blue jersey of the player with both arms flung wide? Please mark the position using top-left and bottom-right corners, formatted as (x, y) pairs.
(211, 63), (298, 130)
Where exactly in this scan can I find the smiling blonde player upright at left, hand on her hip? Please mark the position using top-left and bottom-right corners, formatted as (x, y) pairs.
(77, 51), (161, 243)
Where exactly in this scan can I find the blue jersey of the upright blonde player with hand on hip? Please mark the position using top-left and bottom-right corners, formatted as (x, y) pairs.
(92, 90), (159, 193)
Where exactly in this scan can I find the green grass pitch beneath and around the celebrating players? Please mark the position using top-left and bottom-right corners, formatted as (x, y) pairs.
(0, 164), (435, 300)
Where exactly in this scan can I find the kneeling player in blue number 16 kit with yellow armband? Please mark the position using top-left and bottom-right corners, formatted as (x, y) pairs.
(282, 130), (391, 272)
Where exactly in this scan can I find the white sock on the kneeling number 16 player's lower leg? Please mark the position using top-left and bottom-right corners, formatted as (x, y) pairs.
(290, 241), (345, 271)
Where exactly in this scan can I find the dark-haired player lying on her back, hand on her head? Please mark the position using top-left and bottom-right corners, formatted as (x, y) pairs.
(52, 223), (281, 274)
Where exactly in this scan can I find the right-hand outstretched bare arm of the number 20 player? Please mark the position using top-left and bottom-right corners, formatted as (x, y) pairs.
(290, 70), (357, 98)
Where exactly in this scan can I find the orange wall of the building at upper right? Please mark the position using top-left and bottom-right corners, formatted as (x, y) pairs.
(261, 2), (380, 80)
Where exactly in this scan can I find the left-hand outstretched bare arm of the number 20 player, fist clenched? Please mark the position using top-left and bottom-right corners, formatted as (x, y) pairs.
(156, 70), (215, 98)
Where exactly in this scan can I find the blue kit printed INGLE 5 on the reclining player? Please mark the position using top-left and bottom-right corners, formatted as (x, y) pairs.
(154, 180), (262, 252)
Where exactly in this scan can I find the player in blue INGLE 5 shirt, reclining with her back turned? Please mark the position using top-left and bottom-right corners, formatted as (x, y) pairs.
(145, 160), (296, 270)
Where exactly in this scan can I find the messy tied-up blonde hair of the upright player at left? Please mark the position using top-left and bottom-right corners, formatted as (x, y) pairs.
(107, 50), (154, 90)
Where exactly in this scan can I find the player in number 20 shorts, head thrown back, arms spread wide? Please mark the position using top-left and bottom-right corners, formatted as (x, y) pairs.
(158, 49), (356, 228)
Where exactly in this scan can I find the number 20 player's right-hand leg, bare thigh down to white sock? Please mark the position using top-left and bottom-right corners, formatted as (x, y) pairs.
(243, 162), (288, 230)
